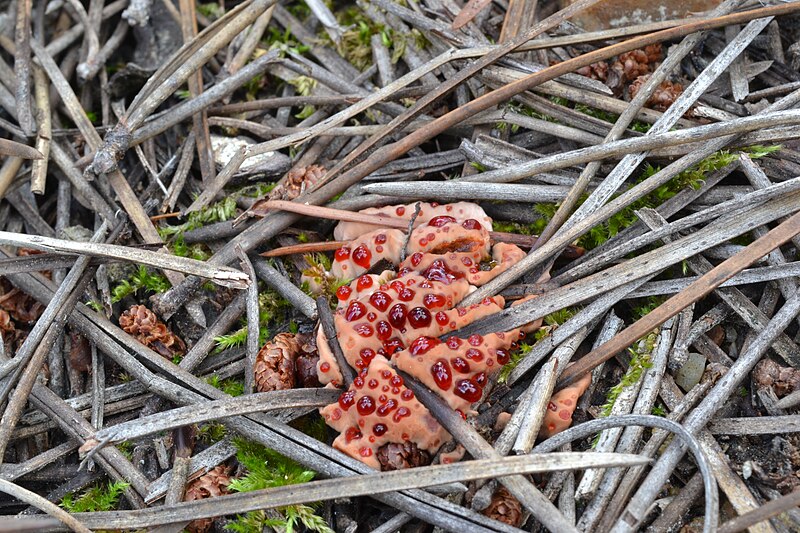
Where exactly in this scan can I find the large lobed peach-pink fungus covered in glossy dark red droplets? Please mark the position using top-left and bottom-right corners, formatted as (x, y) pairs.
(317, 202), (556, 469)
